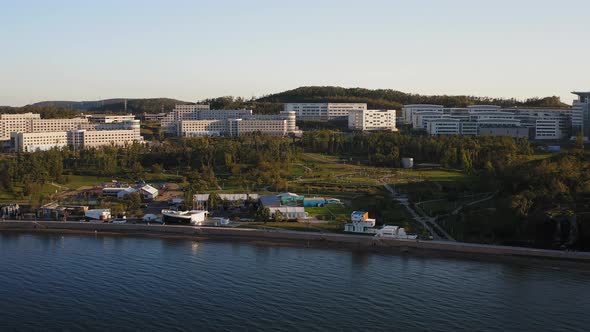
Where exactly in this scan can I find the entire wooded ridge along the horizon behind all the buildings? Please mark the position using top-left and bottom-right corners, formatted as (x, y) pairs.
(5, 86), (569, 116)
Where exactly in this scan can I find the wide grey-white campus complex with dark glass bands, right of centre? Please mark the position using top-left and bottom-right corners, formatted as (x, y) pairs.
(403, 105), (572, 140)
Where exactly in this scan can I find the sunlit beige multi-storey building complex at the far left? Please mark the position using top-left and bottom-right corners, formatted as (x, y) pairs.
(0, 113), (143, 152)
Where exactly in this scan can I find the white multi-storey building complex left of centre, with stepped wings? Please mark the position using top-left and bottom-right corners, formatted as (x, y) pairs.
(162, 105), (301, 137)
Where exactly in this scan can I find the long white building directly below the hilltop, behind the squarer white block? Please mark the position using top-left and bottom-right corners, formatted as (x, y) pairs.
(284, 103), (367, 121)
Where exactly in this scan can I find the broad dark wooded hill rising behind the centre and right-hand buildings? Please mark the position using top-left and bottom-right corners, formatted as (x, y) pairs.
(257, 86), (569, 109)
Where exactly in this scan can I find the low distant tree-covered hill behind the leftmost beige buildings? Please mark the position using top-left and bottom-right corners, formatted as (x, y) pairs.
(31, 98), (190, 114)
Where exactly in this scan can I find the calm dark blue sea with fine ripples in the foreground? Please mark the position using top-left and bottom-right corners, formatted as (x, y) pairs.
(0, 233), (590, 331)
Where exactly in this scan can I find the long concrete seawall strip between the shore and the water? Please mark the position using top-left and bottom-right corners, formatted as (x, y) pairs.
(0, 221), (590, 263)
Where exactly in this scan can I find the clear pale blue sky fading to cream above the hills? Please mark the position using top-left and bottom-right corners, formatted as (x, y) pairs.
(0, 0), (590, 106)
